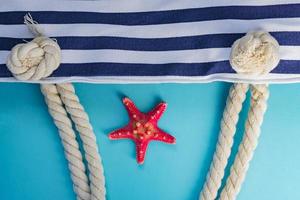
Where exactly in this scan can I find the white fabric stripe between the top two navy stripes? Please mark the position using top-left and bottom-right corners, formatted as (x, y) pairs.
(0, 18), (300, 38)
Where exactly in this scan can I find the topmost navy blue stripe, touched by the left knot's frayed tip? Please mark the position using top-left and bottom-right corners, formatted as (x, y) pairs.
(0, 4), (300, 25)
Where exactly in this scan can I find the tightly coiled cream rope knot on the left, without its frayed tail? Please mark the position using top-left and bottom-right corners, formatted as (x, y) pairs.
(7, 37), (61, 80)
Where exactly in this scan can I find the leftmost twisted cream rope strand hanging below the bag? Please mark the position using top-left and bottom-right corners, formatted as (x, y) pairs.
(41, 84), (90, 200)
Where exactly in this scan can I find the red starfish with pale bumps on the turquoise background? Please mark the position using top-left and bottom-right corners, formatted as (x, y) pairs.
(108, 97), (175, 164)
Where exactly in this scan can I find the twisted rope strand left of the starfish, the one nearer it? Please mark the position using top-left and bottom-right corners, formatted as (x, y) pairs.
(56, 83), (106, 200)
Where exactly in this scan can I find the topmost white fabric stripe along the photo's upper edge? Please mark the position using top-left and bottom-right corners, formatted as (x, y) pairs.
(0, 0), (300, 12)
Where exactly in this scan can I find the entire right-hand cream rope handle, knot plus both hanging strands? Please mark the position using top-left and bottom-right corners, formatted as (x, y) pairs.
(199, 31), (279, 200)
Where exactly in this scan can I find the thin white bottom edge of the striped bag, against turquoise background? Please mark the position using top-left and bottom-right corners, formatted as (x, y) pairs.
(0, 74), (300, 84)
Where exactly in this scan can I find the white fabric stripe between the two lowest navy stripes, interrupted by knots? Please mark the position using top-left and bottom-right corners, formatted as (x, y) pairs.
(0, 46), (300, 64)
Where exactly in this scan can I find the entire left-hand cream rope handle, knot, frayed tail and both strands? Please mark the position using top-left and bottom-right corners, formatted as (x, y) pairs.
(7, 14), (106, 200)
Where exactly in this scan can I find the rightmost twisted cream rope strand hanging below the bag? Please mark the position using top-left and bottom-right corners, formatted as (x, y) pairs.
(220, 85), (269, 200)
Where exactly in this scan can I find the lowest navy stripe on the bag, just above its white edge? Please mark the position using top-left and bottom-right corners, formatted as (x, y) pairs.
(0, 60), (300, 77)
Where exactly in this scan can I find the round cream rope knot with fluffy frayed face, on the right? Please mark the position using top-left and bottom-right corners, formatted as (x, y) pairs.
(230, 31), (280, 75)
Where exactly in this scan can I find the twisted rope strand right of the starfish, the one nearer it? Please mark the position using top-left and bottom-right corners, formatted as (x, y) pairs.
(199, 83), (249, 200)
